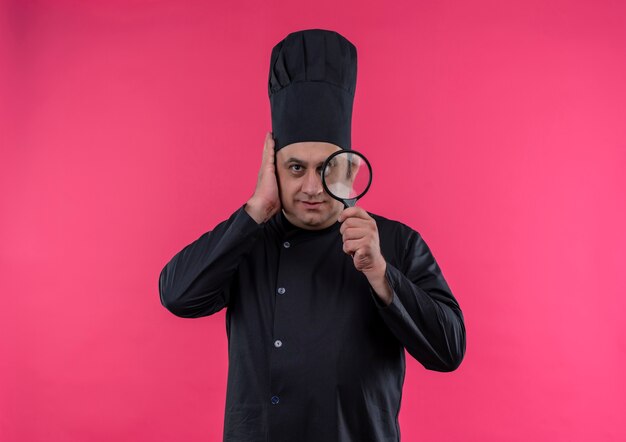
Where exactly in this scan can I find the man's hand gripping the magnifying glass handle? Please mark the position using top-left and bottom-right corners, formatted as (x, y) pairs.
(338, 207), (393, 305)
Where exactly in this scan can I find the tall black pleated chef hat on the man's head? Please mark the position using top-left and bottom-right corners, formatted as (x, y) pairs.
(268, 29), (357, 150)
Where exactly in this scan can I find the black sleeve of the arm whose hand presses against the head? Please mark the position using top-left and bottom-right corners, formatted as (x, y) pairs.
(159, 206), (263, 318)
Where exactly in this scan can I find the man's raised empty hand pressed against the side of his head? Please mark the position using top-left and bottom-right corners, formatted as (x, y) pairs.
(245, 132), (280, 224)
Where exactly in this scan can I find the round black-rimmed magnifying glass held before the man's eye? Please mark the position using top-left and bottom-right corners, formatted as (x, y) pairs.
(322, 150), (372, 207)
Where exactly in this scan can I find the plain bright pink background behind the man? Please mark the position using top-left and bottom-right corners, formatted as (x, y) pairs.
(0, 0), (626, 442)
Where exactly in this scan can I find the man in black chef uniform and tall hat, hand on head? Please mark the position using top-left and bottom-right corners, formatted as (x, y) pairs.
(159, 30), (465, 442)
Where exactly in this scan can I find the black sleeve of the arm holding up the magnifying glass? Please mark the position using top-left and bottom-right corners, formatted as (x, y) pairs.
(372, 230), (465, 371)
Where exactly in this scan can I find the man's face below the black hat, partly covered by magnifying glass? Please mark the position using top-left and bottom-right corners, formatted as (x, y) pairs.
(276, 141), (343, 230)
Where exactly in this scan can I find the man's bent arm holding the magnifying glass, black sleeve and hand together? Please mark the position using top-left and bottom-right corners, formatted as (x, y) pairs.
(339, 207), (465, 371)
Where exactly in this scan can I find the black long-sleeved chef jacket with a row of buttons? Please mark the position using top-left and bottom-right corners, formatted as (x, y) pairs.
(159, 208), (465, 442)
